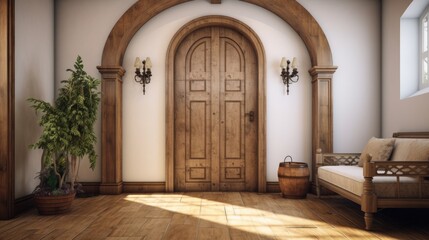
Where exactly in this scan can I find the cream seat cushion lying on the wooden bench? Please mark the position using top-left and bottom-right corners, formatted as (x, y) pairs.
(317, 166), (429, 198)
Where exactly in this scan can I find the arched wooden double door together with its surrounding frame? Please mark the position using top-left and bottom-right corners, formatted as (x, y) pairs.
(166, 16), (266, 192)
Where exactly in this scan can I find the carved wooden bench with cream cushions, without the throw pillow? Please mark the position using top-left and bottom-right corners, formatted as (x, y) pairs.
(316, 132), (429, 230)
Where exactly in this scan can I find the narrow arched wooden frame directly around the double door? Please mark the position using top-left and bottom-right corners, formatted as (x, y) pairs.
(165, 15), (267, 192)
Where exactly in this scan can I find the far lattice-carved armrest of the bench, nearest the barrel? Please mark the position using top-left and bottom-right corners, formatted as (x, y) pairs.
(316, 148), (360, 167)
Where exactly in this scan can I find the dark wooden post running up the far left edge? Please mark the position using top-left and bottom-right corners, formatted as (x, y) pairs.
(0, 0), (15, 220)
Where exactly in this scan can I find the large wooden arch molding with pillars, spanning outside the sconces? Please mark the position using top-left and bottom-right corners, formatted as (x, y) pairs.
(98, 0), (336, 194)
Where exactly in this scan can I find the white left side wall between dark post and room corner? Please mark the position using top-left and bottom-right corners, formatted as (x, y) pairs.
(15, 0), (54, 198)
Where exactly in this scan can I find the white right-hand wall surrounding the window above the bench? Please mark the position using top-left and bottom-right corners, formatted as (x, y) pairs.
(382, 0), (429, 137)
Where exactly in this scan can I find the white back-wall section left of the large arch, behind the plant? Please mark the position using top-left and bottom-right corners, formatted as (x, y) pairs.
(55, 0), (136, 182)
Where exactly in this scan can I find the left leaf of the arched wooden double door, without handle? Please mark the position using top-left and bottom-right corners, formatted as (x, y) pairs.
(174, 26), (211, 191)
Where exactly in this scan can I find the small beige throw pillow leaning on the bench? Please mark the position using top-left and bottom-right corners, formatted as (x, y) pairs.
(358, 137), (395, 167)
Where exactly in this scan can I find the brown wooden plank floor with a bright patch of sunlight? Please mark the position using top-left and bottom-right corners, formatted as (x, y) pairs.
(0, 192), (429, 240)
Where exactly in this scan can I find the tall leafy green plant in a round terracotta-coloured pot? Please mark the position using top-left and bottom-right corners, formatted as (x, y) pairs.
(29, 56), (100, 214)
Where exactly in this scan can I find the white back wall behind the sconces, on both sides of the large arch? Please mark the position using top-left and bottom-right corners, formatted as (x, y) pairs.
(55, 0), (380, 181)
